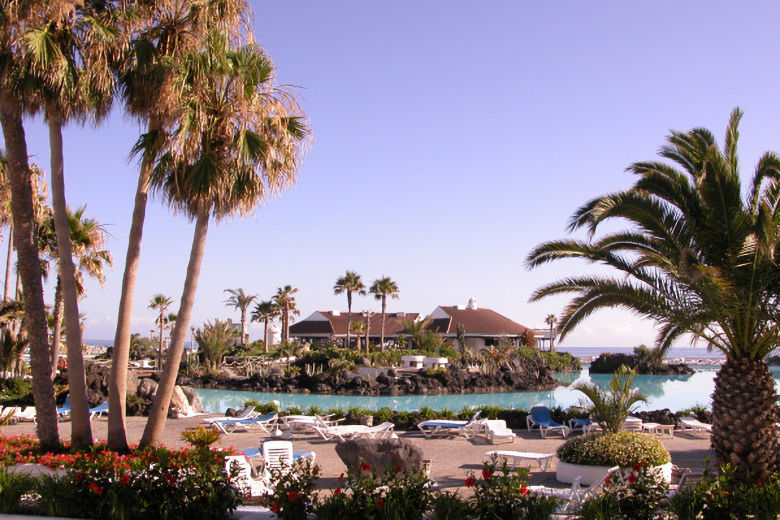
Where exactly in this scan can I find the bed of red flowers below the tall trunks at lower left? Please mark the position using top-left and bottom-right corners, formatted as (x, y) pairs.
(0, 437), (240, 520)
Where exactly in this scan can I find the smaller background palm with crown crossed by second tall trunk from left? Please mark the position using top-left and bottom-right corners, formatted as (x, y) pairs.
(38, 206), (114, 380)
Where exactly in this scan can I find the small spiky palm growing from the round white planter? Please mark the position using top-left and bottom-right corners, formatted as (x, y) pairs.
(572, 365), (647, 433)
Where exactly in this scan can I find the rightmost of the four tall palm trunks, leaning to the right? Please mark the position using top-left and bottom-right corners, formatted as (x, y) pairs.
(140, 210), (209, 447)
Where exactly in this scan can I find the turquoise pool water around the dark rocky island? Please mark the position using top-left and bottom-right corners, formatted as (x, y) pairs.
(197, 367), (780, 413)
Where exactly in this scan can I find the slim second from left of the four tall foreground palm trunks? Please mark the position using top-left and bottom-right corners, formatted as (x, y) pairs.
(47, 116), (92, 448)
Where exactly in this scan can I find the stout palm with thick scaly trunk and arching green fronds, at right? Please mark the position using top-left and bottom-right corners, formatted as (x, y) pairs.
(527, 109), (780, 478)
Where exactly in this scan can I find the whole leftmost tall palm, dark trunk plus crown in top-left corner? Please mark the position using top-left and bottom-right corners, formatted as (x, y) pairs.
(0, 1), (63, 450)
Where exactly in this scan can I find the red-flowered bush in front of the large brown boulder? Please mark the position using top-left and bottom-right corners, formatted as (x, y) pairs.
(315, 462), (431, 520)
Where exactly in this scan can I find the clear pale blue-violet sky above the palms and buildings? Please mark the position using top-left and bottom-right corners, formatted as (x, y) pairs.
(13, 1), (780, 346)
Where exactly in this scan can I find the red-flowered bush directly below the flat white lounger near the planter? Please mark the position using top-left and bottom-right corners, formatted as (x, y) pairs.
(465, 460), (558, 520)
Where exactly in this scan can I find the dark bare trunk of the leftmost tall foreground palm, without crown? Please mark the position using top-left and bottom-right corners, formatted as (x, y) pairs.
(0, 92), (60, 450)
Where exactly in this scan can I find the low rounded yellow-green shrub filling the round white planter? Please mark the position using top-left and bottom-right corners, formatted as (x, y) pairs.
(558, 432), (671, 468)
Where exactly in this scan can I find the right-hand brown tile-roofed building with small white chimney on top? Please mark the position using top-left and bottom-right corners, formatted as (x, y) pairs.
(426, 298), (536, 350)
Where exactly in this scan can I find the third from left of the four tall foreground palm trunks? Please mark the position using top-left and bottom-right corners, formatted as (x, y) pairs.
(108, 121), (159, 452)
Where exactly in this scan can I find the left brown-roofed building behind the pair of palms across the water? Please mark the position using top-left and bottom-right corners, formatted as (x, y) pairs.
(290, 311), (420, 344)
